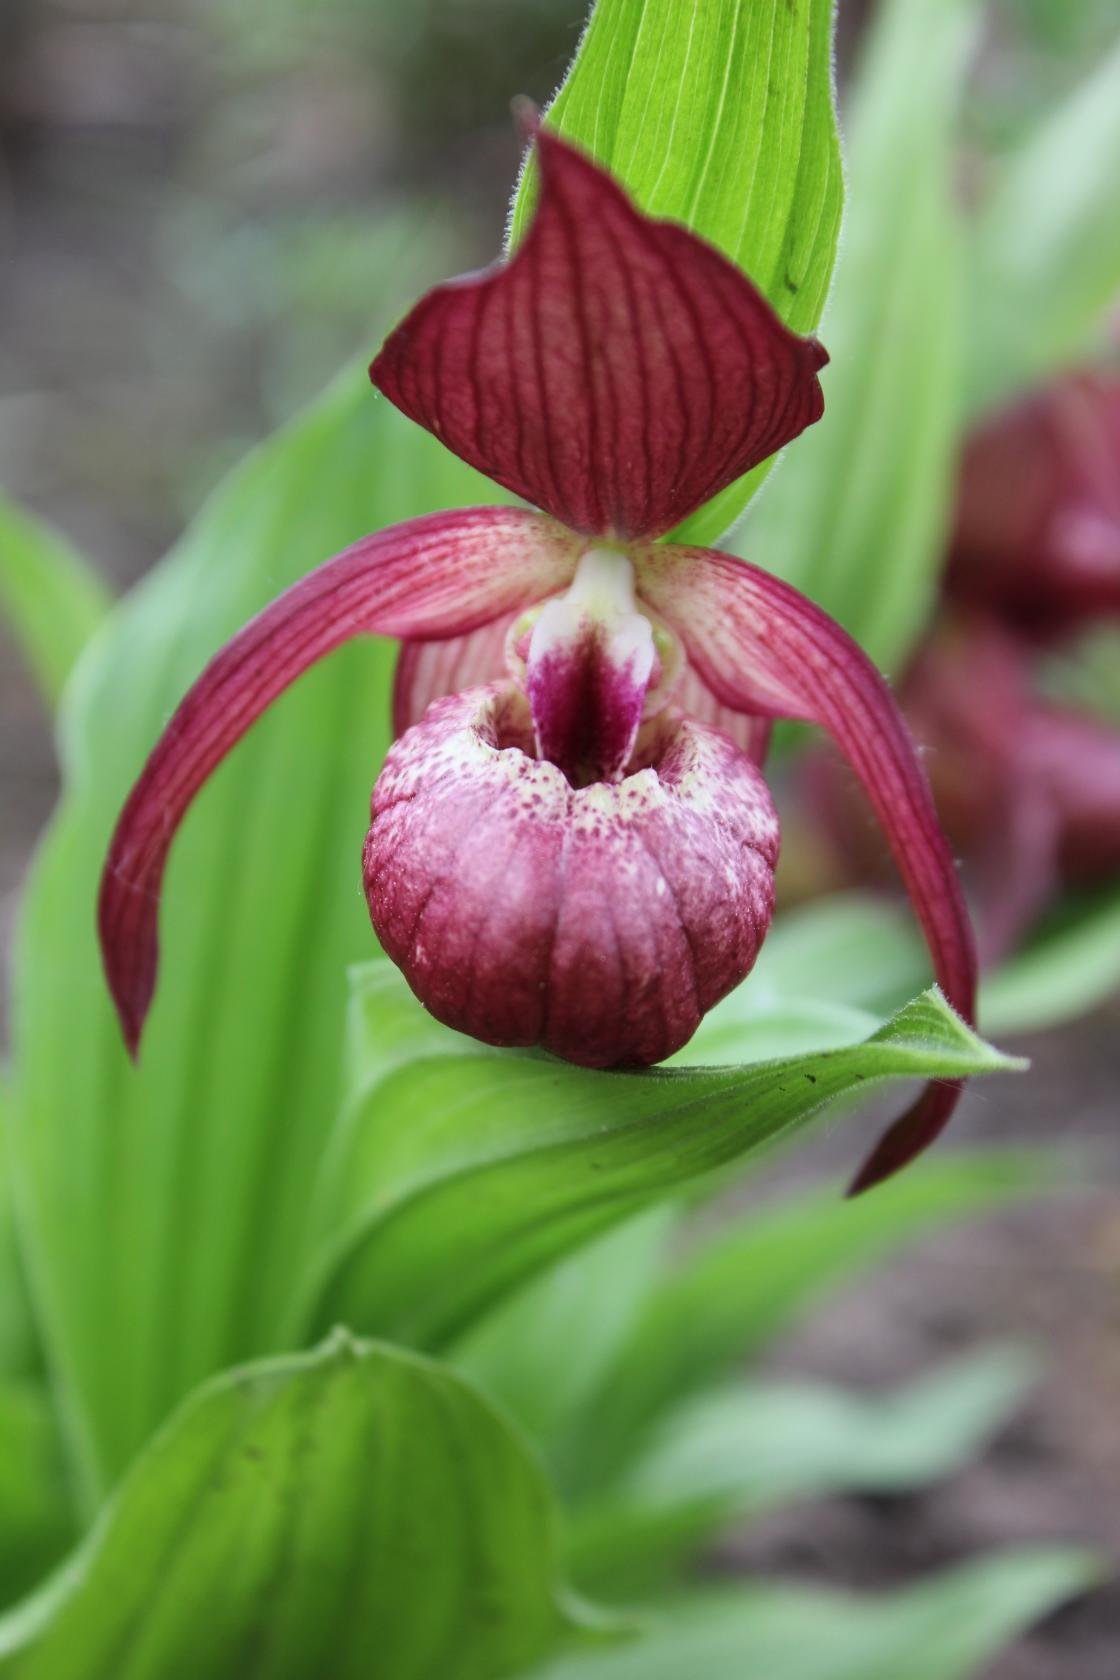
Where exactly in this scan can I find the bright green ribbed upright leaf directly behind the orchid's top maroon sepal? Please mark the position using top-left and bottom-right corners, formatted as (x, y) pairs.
(510, 0), (843, 543)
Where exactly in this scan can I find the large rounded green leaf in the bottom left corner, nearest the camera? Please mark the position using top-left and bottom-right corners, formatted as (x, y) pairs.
(0, 1331), (614, 1680)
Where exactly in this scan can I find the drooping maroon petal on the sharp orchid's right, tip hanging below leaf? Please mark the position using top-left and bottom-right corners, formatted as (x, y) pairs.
(635, 546), (976, 1193)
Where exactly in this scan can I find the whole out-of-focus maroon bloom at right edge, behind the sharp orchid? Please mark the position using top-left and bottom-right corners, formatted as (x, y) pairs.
(806, 373), (1120, 963)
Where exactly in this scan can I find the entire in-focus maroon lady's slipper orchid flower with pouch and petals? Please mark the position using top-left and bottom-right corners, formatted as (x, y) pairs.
(101, 131), (974, 1188)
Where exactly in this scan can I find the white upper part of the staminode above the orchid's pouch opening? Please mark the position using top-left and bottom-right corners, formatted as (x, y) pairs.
(527, 548), (655, 687)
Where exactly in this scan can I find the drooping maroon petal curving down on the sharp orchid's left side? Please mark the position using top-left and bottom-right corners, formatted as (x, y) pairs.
(99, 507), (579, 1053)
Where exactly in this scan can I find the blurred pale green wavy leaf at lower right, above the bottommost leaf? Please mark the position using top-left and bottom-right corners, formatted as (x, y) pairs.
(568, 1347), (1034, 1596)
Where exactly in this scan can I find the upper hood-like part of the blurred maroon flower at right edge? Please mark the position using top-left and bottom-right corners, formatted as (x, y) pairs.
(947, 373), (1120, 638)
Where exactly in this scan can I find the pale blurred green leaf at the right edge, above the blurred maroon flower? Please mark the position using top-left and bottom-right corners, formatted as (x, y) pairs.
(967, 40), (1120, 412)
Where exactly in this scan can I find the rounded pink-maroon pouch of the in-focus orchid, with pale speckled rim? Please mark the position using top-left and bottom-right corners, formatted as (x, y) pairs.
(364, 684), (777, 1067)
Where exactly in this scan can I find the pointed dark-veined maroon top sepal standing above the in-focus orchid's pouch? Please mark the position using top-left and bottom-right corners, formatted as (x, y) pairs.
(369, 129), (828, 538)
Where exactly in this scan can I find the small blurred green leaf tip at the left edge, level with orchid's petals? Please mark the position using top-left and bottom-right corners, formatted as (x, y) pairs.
(0, 496), (109, 707)
